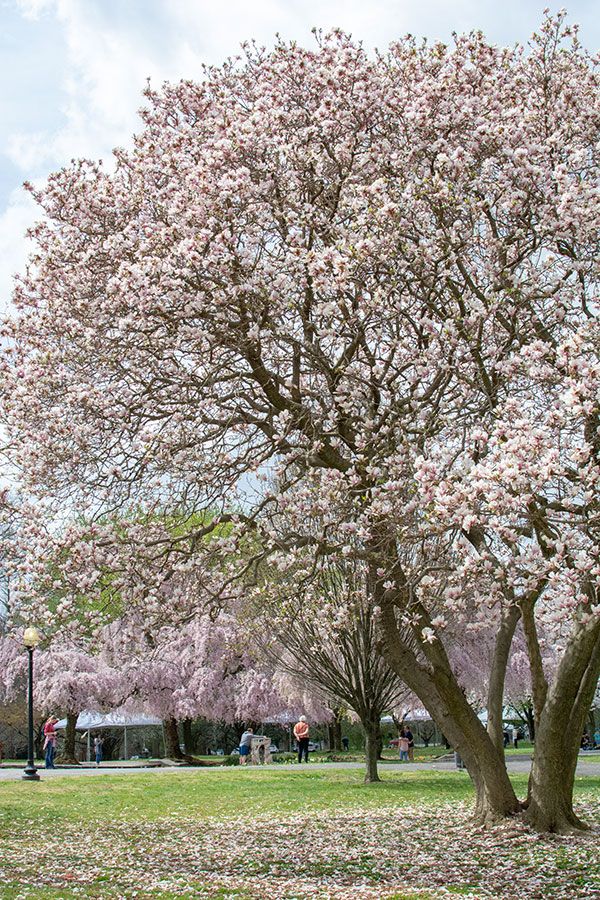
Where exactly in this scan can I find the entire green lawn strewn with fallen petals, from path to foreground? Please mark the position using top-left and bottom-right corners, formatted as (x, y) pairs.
(0, 766), (600, 900)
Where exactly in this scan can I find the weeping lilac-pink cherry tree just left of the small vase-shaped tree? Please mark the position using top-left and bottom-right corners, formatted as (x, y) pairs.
(102, 613), (327, 758)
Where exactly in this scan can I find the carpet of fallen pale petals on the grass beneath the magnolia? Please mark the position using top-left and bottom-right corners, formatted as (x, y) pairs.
(0, 798), (600, 900)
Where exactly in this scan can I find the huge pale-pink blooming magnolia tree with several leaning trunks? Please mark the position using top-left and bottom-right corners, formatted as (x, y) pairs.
(4, 15), (600, 830)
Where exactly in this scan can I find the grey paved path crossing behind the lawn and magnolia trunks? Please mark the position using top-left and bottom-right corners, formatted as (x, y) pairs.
(0, 756), (600, 781)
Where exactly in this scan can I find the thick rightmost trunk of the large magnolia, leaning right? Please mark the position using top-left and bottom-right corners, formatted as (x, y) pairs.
(525, 622), (600, 833)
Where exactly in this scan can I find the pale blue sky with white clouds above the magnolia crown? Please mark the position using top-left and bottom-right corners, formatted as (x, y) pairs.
(0, 0), (600, 309)
